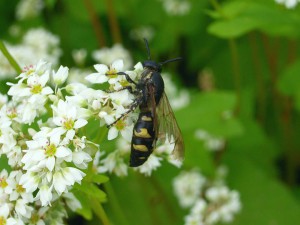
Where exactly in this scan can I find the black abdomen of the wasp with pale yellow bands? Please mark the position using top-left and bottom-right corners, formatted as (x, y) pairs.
(130, 111), (155, 167)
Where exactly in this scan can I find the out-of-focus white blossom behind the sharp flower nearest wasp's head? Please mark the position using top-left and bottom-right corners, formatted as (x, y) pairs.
(92, 44), (132, 70)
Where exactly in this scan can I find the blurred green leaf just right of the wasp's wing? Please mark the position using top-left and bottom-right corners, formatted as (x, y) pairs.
(176, 91), (243, 138)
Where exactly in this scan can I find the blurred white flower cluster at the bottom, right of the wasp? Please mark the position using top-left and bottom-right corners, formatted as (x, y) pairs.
(173, 170), (241, 225)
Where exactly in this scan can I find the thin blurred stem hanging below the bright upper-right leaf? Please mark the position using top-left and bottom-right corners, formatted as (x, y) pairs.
(228, 39), (242, 115)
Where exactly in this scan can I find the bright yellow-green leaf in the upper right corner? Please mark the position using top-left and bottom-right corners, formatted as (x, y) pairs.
(208, 1), (300, 38)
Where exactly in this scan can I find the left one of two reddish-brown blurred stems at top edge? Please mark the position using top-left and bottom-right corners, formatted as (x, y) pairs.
(83, 0), (106, 48)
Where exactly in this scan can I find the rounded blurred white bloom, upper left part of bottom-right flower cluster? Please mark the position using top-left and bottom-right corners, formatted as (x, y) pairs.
(173, 171), (206, 208)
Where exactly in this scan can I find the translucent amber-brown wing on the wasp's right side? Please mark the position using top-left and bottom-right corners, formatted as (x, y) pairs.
(156, 93), (184, 161)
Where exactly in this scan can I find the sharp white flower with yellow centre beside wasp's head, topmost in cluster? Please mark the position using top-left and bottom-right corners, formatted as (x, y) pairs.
(85, 59), (124, 84)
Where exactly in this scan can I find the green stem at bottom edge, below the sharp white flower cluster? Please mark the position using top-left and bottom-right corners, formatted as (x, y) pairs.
(103, 182), (129, 225)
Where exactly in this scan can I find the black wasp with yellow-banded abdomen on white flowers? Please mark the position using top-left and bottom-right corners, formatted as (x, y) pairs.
(108, 39), (184, 167)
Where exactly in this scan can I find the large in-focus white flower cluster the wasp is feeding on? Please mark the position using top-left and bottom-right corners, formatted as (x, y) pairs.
(0, 56), (188, 224)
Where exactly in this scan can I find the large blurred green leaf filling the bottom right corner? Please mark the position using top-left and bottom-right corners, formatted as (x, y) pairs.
(226, 152), (300, 225)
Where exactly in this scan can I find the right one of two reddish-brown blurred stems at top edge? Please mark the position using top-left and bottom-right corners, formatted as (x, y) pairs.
(105, 0), (122, 43)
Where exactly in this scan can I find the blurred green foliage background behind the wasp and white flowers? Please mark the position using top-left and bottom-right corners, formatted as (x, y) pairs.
(0, 0), (300, 225)
